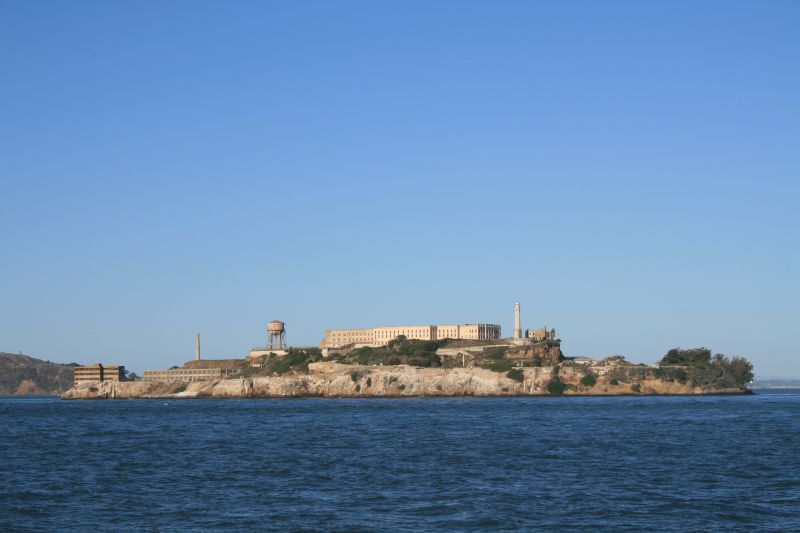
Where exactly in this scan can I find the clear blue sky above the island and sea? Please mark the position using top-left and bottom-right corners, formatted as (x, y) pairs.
(0, 0), (800, 378)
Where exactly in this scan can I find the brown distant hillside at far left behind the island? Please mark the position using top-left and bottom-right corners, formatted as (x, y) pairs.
(0, 352), (74, 396)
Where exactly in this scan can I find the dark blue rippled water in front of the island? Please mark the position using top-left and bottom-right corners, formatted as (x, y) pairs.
(0, 390), (800, 532)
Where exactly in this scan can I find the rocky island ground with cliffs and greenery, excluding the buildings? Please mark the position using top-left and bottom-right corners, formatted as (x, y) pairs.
(61, 335), (753, 400)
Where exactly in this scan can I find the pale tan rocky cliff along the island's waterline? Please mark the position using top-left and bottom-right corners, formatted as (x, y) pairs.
(62, 362), (743, 399)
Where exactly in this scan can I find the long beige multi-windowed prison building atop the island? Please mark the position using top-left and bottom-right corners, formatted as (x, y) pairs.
(319, 324), (500, 349)
